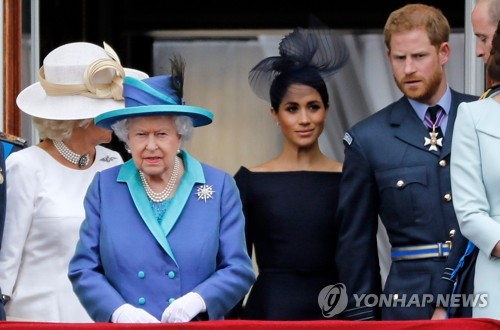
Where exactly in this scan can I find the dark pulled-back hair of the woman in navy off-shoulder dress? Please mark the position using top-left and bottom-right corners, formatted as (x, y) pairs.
(269, 67), (329, 112)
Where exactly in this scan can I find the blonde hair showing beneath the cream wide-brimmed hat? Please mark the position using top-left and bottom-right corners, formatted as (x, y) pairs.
(33, 117), (94, 141)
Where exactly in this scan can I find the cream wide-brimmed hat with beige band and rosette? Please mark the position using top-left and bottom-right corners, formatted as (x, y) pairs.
(16, 42), (148, 120)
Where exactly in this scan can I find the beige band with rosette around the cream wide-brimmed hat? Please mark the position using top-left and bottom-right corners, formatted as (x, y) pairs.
(38, 59), (125, 101)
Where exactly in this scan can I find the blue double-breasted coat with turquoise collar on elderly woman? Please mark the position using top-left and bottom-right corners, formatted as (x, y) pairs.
(69, 152), (255, 322)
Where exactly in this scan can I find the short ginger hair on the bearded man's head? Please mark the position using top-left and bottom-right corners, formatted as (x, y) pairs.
(384, 4), (450, 49)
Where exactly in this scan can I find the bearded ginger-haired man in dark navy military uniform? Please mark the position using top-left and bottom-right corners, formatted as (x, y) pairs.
(336, 4), (477, 320)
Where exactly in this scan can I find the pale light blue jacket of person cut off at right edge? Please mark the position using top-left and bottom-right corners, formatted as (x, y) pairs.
(451, 97), (500, 319)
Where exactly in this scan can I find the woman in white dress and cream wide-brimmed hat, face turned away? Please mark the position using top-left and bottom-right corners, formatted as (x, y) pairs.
(0, 42), (147, 322)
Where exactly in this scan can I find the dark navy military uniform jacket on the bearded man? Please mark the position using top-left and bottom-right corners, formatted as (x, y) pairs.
(337, 90), (477, 319)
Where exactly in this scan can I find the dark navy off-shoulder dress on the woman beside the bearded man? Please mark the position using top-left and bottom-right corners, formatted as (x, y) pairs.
(234, 167), (341, 320)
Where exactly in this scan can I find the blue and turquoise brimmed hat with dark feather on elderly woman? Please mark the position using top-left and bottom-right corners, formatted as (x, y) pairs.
(95, 57), (214, 129)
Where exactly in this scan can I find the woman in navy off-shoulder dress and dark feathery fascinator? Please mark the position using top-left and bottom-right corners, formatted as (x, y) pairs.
(235, 18), (348, 320)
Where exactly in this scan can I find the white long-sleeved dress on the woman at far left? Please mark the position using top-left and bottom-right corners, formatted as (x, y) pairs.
(0, 146), (123, 323)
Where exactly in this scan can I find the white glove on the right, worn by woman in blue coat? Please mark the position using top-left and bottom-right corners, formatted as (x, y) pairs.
(161, 292), (207, 323)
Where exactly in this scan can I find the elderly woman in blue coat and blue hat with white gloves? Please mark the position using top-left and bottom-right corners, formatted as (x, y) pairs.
(69, 56), (255, 323)
